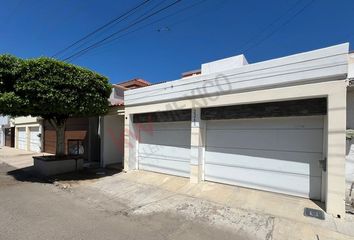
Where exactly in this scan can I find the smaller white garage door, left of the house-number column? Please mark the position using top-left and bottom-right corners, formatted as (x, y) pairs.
(138, 122), (191, 177)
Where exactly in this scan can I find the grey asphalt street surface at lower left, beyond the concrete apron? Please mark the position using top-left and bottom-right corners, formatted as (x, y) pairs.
(0, 163), (248, 240)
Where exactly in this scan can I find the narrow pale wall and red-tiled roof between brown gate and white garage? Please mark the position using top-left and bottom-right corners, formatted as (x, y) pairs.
(100, 78), (150, 167)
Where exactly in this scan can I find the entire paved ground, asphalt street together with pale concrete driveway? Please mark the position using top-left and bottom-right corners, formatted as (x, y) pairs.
(0, 148), (354, 240)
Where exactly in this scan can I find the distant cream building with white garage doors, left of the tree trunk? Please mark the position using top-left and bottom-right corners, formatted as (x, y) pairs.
(12, 116), (43, 152)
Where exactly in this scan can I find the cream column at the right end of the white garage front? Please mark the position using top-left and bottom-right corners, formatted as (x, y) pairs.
(326, 86), (347, 218)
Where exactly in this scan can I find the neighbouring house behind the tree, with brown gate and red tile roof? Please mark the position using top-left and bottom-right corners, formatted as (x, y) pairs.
(43, 79), (150, 167)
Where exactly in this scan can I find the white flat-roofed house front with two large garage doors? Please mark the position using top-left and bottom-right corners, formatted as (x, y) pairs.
(124, 44), (352, 217)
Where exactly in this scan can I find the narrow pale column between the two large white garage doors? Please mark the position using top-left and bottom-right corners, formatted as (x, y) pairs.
(190, 108), (205, 183)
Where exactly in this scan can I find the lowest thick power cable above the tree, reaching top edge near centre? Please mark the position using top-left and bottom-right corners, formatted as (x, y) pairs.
(64, 0), (182, 61)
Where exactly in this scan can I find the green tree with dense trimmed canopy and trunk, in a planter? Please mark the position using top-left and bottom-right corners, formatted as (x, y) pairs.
(0, 55), (111, 156)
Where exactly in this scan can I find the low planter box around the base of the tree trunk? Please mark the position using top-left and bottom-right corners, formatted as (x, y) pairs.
(33, 156), (84, 176)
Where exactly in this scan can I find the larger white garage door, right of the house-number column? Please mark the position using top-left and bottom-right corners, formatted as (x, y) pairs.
(205, 116), (324, 199)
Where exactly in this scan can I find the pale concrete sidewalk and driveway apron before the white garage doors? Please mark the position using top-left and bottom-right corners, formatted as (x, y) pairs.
(70, 171), (354, 240)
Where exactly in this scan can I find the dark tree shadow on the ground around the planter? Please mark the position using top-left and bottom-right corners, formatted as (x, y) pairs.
(7, 166), (122, 183)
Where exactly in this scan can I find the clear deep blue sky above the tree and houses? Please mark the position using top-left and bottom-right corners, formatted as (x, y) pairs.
(0, 0), (354, 83)
